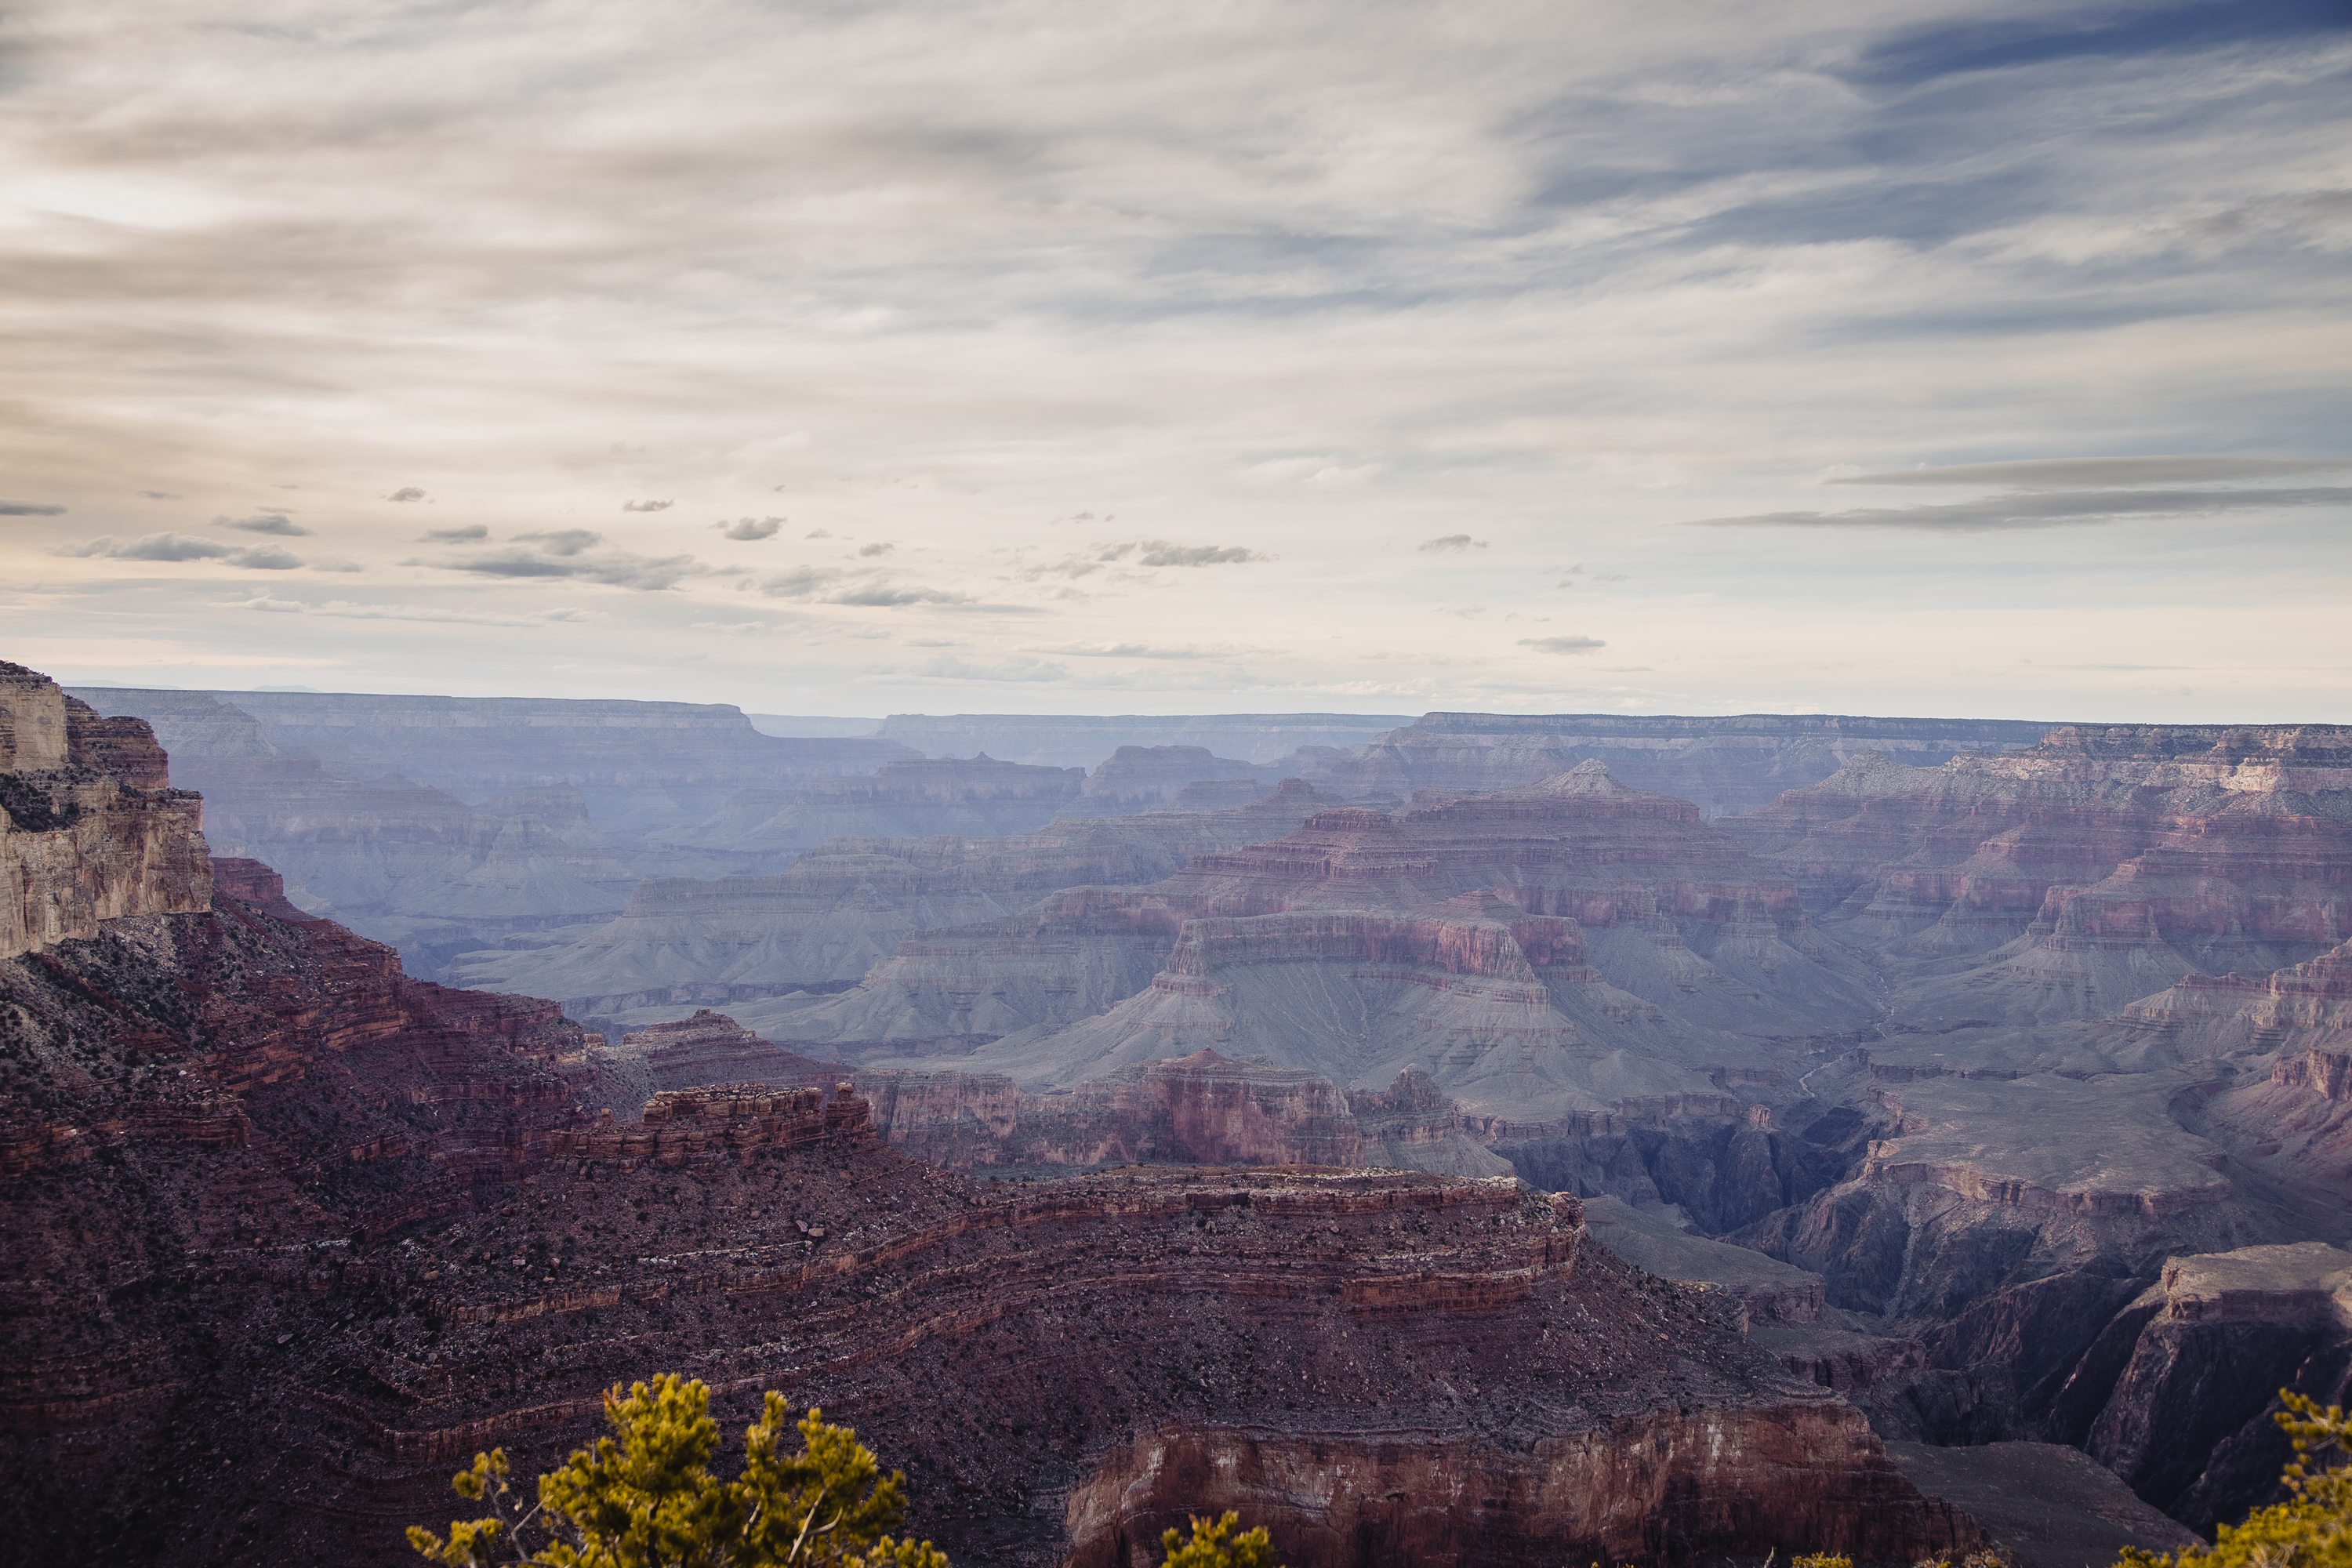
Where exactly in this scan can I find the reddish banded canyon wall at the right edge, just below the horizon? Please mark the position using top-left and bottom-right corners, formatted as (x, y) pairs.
(1738, 727), (2352, 1022)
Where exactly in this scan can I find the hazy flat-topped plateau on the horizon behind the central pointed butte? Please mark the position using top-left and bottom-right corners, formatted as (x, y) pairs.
(1308, 713), (2046, 815)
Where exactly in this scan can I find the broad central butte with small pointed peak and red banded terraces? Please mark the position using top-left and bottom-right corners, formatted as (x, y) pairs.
(837, 764), (1877, 1121)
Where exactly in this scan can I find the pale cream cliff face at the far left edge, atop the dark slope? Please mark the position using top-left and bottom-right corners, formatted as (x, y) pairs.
(0, 663), (212, 959)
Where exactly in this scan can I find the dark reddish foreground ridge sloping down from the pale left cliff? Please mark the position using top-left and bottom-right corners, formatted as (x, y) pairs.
(0, 667), (1980, 1568)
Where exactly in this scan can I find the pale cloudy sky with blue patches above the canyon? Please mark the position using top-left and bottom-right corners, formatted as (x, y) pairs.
(0, 0), (2352, 722)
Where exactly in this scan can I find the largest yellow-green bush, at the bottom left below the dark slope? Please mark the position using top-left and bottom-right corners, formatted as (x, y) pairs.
(409, 1373), (948, 1568)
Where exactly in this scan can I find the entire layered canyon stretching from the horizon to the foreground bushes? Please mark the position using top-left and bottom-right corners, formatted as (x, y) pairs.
(18, 668), (2352, 1568)
